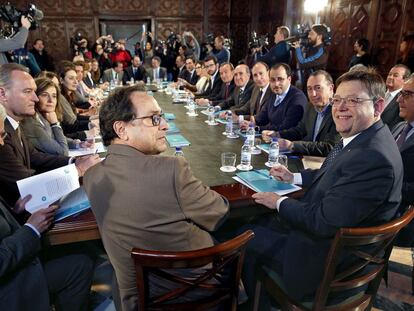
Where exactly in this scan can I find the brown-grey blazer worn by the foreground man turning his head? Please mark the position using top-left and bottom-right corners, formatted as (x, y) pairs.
(84, 144), (228, 310)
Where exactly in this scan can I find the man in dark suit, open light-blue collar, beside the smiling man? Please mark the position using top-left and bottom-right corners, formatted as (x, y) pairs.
(262, 70), (340, 157)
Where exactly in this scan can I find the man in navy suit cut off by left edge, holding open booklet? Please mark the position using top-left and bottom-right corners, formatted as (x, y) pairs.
(0, 105), (93, 311)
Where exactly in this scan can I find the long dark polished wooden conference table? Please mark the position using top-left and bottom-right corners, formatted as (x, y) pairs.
(45, 92), (303, 245)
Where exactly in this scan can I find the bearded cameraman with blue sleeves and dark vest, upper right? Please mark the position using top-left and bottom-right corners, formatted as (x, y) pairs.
(292, 24), (329, 85)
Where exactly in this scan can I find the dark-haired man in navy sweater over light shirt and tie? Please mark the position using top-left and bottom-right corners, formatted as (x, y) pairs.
(241, 63), (307, 131)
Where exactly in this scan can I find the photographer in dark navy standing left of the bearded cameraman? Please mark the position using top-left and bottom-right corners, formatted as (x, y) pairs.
(256, 26), (290, 68)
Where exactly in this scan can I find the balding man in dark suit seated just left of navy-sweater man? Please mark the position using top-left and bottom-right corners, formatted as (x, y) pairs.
(234, 62), (272, 118)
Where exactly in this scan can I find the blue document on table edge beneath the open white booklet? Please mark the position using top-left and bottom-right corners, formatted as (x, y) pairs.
(55, 187), (91, 221)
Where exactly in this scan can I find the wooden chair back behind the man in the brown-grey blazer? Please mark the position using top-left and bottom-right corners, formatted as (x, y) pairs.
(131, 230), (254, 311)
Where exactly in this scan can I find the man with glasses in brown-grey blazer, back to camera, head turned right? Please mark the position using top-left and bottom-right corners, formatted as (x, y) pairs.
(84, 86), (228, 310)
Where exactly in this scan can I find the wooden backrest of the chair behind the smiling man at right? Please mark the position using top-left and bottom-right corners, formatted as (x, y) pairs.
(312, 206), (414, 310)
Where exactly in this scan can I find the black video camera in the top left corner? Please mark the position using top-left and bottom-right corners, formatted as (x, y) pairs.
(0, 2), (43, 37)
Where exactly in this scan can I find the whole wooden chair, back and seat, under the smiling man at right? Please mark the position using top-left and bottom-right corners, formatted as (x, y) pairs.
(254, 206), (414, 311)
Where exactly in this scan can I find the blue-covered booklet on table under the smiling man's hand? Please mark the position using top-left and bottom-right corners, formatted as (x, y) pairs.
(233, 169), (301, 195)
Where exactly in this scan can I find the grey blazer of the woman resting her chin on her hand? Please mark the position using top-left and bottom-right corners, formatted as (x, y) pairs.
(21, 113), (70, 156)
